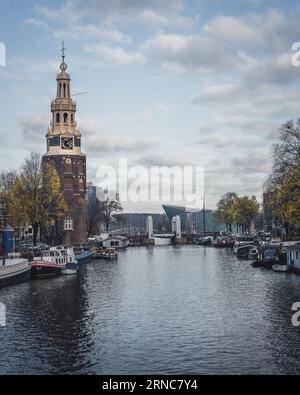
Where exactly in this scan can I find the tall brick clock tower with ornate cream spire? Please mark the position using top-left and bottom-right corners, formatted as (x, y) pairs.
(43, 45), (86, 245)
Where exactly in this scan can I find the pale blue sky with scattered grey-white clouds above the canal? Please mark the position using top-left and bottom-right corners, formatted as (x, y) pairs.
(0, 0), (300, 211)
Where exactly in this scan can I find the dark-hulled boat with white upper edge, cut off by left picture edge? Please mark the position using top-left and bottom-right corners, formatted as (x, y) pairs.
(0, 254), (31, 288)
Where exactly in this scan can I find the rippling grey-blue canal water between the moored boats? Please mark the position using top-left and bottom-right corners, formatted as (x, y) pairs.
(0, 246), (300, 374)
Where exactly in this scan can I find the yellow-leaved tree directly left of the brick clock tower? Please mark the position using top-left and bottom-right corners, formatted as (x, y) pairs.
(10, 153), (67, 245)
